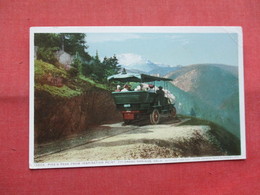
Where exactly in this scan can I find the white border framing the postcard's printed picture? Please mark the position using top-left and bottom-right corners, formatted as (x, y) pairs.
(29, 26), (246, 169)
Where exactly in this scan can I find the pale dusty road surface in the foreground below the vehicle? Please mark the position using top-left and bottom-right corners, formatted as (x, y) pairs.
(35, 121), (219, 163)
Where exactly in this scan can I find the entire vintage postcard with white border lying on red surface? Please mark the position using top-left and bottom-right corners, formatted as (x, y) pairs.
(29, 26), (246, 169)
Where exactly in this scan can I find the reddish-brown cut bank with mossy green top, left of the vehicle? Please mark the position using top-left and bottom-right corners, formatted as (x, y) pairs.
(34, 60), (121, 143)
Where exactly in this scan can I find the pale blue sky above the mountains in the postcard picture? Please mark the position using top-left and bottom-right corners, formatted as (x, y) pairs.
(86, 33), (238, 66)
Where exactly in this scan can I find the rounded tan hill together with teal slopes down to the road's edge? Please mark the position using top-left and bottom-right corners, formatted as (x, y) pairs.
(166, 64), (240, 137)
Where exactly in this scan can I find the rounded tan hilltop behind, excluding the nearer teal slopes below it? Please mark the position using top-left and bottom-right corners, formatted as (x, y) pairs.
(167, 64), (238, 106)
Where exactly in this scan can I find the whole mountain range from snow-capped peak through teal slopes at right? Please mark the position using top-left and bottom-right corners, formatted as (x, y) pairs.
(117, 54), (240, 137)
